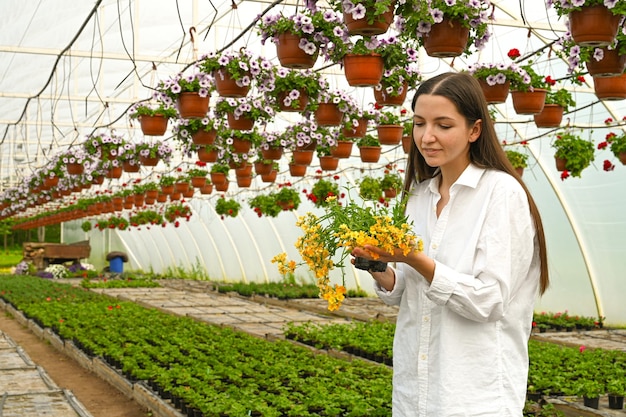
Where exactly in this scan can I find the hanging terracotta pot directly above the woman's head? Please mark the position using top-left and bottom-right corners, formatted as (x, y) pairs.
(423, 17), (469, 58)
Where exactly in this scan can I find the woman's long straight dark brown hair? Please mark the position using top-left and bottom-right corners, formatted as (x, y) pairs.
(404, 72), (550, 294)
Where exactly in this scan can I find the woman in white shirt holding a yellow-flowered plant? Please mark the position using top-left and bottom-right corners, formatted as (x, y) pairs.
(352, 73), (548, 417)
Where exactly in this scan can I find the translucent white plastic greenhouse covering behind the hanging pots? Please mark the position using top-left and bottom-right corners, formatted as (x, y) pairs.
(0, 0), (626, 323)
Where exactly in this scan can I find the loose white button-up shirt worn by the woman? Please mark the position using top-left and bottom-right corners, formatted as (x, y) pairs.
(376, 164), (540, 417)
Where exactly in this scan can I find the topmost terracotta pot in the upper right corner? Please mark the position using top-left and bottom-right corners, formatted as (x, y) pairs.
(569, 4), (621, 47)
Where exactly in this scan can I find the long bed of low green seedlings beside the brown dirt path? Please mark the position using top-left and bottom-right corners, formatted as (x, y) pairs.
(0, 276), (391, 417)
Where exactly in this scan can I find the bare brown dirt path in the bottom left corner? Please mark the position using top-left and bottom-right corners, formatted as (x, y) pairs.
(0, 314), (152, 417)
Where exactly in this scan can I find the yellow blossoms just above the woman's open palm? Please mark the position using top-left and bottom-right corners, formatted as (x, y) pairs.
(337, 216), (416, 259)
